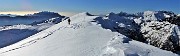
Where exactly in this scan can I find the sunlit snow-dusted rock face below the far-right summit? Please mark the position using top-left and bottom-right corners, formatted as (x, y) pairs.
(141, 21), (180, 51)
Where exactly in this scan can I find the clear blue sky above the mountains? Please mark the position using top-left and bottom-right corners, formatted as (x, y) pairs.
(0, 0), (180, 14)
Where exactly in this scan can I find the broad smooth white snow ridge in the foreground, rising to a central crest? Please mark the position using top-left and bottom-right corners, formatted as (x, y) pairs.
(0, 12), (178, 56)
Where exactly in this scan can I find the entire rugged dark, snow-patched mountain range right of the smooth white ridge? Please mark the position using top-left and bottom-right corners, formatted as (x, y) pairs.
(95, 11), (180, 53)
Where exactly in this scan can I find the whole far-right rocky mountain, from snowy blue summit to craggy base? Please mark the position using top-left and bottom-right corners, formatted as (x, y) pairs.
(139, 11), (180, 51)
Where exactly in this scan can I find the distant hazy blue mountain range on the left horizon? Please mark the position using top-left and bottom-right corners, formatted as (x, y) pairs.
(0, 11), (65, 26)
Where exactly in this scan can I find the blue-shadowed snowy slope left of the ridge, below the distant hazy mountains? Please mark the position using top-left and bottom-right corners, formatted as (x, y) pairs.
(0, 17), (62, 48)
